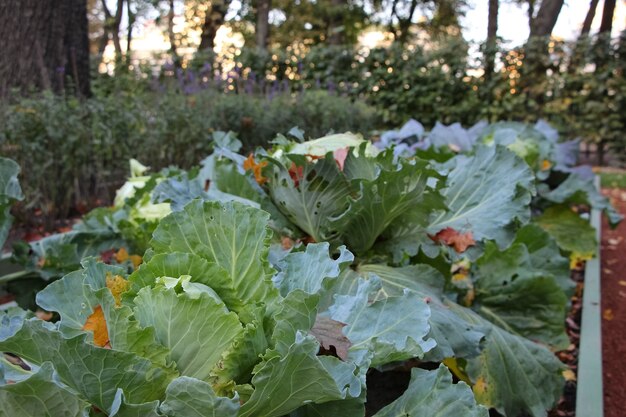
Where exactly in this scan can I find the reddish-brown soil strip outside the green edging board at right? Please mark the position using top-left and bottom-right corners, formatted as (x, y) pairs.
(601, 189), (626, 417)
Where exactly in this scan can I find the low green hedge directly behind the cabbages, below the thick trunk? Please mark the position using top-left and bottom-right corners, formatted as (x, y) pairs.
(0, 89), (377, 221)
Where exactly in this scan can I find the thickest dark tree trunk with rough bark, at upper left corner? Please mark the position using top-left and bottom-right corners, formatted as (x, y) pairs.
(0, 0), (90, 96)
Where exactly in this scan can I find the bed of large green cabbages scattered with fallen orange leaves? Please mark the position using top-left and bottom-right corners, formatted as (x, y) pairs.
(0, 123), (619, 417)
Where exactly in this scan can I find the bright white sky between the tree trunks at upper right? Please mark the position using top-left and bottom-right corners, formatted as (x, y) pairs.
(461, 0), (626, 45)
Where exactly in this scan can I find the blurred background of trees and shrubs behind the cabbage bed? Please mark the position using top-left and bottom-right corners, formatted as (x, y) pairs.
(0, 0), (626, 221)
